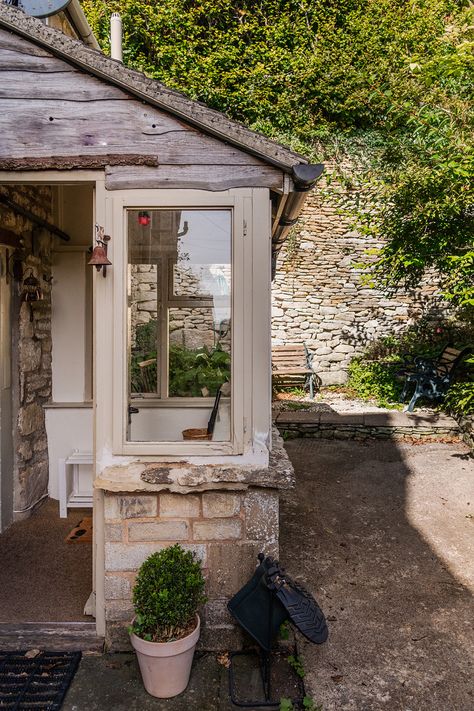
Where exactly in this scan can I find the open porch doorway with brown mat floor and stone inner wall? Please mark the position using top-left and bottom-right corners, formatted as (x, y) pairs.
(0, 182), (95, 637)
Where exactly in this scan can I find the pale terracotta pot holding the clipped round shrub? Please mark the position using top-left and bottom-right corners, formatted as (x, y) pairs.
(130, 615), (201, 699)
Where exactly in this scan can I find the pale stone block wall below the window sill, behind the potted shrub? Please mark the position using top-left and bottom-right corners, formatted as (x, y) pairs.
(104, 488), (278, 650)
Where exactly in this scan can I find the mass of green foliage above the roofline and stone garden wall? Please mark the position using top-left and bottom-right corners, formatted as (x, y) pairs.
(82, 0), (474, 309)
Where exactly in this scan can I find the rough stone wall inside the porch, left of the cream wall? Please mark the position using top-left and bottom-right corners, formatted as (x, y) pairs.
(0, 186), (52, 519)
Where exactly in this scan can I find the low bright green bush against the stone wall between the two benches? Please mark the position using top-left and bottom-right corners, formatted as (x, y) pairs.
(347, 358), (402, 407)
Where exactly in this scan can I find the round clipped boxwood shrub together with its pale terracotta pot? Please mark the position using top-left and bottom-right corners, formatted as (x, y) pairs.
(130, 544), (205, 699)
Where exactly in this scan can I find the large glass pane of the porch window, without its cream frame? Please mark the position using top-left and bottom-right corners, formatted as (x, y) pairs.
(127, 209), (232, 441)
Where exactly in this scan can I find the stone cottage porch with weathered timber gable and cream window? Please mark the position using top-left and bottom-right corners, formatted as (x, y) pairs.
(0, 4), (322, 648)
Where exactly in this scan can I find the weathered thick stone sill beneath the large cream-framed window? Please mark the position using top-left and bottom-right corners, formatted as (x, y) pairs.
(94, 432), (294, 494)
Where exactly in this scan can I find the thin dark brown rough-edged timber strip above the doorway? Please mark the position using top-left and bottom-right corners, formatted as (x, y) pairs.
(0, 153), (159, 170)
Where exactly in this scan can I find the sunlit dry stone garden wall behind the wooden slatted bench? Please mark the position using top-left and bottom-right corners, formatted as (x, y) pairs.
(272, 184), (447, 384)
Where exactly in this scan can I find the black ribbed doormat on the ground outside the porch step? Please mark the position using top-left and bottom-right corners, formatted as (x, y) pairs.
(0, 649), (81, 711)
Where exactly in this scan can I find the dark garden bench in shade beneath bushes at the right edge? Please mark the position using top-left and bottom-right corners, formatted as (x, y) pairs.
(397, 344), (473, 412)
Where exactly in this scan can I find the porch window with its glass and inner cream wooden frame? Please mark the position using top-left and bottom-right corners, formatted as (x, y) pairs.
(114, 192), (243, 454)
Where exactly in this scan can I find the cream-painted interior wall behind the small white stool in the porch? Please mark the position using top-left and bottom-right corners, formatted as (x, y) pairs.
(46, 185), (94, 499)
